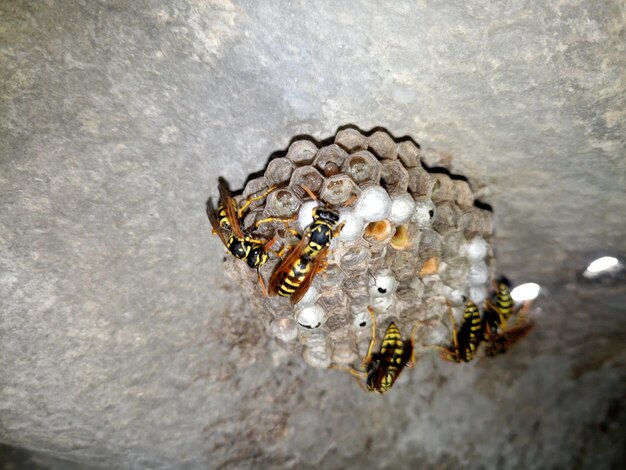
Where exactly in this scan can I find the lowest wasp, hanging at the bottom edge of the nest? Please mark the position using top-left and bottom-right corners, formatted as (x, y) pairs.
(334, 307), (417, 393)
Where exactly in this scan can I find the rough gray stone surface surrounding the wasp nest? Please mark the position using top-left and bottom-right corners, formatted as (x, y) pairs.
(0, 0), (626, 469)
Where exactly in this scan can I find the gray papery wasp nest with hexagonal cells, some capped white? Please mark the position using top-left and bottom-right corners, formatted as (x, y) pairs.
(227, 129), (492, 368)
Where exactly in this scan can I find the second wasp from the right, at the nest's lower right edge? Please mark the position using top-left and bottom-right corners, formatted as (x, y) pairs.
(437, 299), (483, 362)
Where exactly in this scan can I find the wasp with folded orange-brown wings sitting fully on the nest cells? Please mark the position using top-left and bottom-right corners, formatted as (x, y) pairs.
(269, 186), (343, 304)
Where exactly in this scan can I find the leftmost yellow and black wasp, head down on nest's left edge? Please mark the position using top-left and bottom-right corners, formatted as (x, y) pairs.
(206, 180), (276, 295)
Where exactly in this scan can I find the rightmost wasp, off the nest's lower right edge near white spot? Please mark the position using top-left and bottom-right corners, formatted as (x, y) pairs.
(483, 276), (534, 357)
